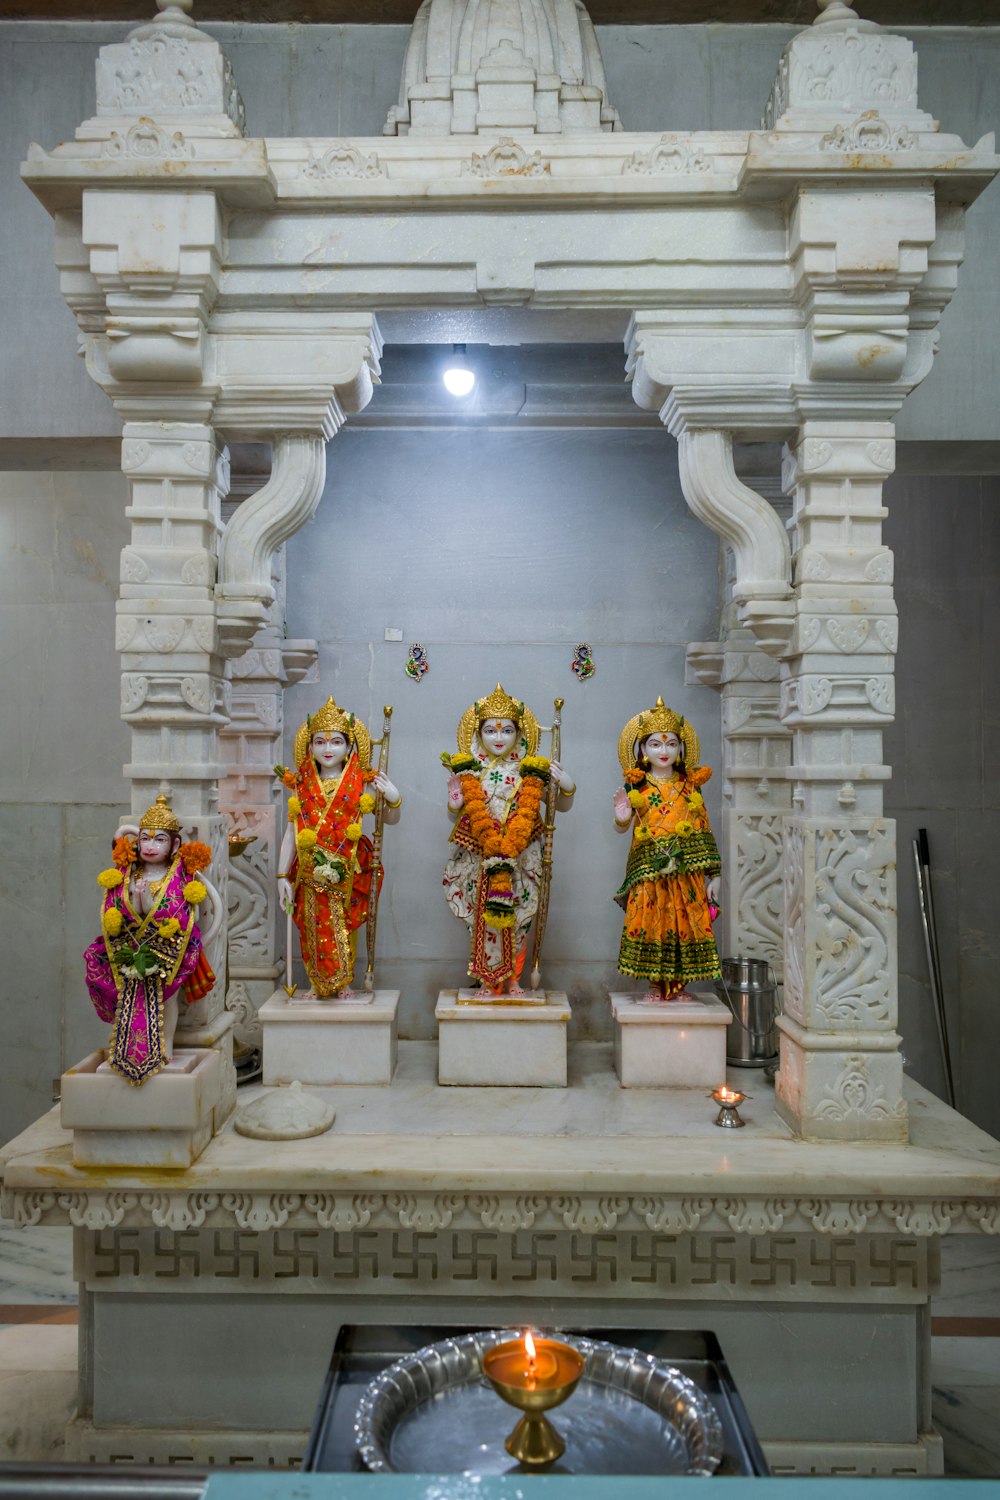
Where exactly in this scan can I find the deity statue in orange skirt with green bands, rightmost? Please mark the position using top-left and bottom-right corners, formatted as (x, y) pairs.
(613, 698), (721, 1001)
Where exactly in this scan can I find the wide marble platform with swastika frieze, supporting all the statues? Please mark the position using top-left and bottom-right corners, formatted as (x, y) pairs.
(1, 1043), (1000, 1475)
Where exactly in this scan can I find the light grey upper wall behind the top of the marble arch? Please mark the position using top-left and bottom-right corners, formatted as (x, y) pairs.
(0, 23), (1000, 450)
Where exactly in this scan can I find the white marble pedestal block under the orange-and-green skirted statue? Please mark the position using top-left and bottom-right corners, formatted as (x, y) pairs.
(612, 995), (733, 1089)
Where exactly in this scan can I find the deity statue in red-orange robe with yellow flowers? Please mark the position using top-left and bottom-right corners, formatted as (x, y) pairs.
(274, 698), (402, 1001)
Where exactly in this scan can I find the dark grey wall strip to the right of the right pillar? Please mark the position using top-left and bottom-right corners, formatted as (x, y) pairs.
(886, 479), (1000, 1136)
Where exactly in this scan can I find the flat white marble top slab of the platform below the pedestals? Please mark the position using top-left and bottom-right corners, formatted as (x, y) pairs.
(0, 1043), (1000, 1212)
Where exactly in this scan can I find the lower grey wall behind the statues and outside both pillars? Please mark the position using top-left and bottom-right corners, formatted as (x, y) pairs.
(0, 428), (1000, 1139)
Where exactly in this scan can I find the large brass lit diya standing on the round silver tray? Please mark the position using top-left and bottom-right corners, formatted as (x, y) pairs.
(483, 1334), (585, 1469)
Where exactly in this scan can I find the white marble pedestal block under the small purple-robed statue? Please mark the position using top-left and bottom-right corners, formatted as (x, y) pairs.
(60, 1047), (222, 1170)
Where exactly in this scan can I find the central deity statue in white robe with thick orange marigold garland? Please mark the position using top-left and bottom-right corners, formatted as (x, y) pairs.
(441, 683), (576, 998)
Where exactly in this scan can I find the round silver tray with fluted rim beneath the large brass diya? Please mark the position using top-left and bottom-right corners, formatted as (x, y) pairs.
(354, 1329), (723, 1475)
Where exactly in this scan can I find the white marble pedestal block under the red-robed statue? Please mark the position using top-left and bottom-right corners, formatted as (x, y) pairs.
(258, 990), (399, 1085)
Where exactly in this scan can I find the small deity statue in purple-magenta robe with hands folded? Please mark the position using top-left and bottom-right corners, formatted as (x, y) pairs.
(84, 795), (222, 1085)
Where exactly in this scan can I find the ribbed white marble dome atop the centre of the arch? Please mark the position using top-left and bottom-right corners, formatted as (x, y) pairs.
(385, 0), (621, 135)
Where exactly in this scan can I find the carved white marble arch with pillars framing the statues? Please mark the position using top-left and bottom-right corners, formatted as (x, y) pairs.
(24, 0), (997, 1142)
